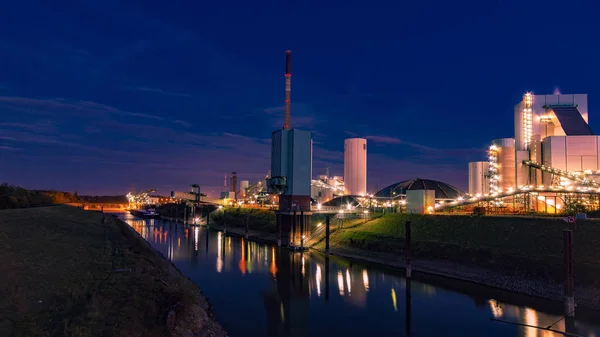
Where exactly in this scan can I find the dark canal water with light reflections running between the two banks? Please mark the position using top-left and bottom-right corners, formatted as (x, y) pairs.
(119, 214), (600, 337)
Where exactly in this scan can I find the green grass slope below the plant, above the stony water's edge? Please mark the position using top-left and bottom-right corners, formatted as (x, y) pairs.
(316, 214), (600, 285)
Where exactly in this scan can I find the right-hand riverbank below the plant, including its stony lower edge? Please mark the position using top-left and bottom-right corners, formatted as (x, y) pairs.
(206, 210), (600, 310)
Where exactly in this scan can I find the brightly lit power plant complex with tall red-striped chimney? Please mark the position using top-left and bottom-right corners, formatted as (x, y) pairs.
(159, 51), (600, 220)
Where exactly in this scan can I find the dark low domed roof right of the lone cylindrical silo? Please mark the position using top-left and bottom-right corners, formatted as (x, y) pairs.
(375, 178), (465, 199)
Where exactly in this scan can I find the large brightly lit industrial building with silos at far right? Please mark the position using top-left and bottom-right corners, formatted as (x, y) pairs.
(462, 93), (600, 213)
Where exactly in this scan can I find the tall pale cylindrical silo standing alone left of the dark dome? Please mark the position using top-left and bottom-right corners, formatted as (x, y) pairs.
(344, 138), (367, 195)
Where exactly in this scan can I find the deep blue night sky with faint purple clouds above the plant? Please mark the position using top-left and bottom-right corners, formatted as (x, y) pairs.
(0, 0), (600, 194)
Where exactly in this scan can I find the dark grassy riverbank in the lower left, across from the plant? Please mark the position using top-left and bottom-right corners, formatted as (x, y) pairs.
(0, 206), (226, 337)
